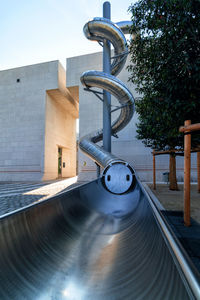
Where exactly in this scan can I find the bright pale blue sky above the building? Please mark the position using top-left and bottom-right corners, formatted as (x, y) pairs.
(0, 0), (135, 70)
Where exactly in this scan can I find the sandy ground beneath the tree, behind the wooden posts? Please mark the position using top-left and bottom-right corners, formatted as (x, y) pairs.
(149, 184), (200, 223)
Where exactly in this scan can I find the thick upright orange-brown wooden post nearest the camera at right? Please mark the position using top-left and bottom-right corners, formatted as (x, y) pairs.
(184, 120), (191, 226)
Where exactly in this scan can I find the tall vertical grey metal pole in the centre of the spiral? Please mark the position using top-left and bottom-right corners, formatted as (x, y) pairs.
(103, 1), (111, 152)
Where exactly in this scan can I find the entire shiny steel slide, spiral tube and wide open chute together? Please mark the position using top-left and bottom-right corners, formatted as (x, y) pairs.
(0, 2), (200, 300)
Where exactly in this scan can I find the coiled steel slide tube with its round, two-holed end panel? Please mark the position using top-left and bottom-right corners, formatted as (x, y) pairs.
(79, 18), (134, 194)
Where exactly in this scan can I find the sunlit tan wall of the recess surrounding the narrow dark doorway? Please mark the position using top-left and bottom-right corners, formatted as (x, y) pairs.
(43, 93), (76, 180)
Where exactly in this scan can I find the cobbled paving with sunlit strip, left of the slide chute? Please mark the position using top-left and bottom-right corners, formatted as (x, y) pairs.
(0, 177), (81, 215)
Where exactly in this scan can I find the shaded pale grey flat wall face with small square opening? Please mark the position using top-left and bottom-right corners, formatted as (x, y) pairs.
(0, 61), (58, 181)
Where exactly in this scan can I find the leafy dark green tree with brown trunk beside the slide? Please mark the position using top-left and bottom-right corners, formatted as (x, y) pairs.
(128, 0), (200, 189)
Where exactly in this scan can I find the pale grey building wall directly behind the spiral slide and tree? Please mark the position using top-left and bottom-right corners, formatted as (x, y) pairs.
(67, 53), (196, 181)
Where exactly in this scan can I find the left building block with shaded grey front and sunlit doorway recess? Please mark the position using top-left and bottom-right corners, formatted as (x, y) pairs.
(0, 61), (78, 181)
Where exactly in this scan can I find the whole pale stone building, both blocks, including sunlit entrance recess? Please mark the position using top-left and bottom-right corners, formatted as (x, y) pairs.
(0, 52), (197, 182)
